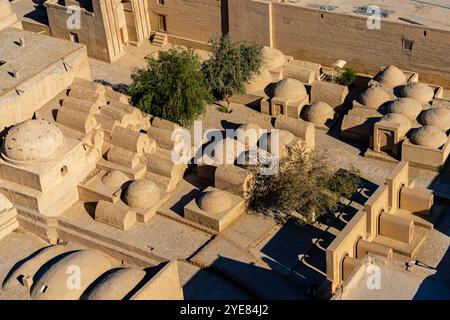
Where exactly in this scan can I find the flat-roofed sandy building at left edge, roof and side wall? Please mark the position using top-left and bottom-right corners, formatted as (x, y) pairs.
(0, 27), (91, 129)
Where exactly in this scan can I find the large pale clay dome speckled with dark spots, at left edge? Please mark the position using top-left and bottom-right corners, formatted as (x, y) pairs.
(3, 120), (64, 161)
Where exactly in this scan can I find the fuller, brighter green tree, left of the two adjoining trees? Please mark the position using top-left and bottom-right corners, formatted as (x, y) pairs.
(128, 48), (213, 125)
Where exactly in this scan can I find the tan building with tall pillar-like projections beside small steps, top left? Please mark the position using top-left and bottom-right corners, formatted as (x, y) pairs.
(45, 0), (150, 62)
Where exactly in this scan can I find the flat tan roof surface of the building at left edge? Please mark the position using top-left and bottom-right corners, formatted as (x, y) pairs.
(0, 28), (83, 96)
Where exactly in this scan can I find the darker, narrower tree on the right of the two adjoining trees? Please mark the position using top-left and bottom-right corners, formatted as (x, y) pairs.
(202, 35), (262, 108)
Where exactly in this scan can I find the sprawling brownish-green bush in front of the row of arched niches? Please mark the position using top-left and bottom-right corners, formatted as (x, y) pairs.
(245, 148), (361, 223)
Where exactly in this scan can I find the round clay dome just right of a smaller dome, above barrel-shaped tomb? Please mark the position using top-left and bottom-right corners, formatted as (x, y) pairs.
(125, 179), (160, 208)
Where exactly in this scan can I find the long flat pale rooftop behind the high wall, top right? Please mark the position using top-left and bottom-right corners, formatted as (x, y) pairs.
(285, 0), (450, 31)
